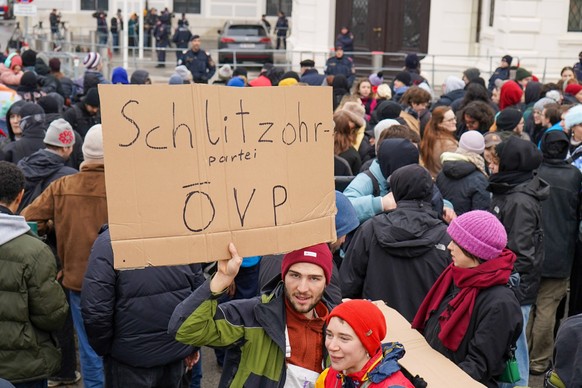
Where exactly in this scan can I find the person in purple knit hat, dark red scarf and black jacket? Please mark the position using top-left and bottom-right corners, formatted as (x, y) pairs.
(412, 210), (522, 387)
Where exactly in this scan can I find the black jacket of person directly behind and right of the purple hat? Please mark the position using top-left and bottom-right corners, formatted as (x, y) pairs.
(488, 176), (550, 305)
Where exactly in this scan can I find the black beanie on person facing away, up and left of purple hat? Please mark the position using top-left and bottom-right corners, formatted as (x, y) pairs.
(390, 164), (433, 203)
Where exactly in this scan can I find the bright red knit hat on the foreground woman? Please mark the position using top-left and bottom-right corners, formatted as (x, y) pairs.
(326, 299), (386, 356)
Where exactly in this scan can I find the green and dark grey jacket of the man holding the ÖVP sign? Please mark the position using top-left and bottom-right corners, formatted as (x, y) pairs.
(168, 281), (332, 388)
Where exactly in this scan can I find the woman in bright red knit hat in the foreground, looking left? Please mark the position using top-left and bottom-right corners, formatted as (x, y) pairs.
(315, 299), (414, 388)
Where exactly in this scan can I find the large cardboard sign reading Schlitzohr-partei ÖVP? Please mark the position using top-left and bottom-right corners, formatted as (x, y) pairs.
(99, 84), (336, 268)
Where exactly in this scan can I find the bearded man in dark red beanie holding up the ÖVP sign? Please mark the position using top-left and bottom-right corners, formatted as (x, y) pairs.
(168, 243), (332, 387)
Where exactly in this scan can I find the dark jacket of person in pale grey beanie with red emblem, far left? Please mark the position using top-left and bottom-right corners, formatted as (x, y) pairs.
(18, 149), (78, 210)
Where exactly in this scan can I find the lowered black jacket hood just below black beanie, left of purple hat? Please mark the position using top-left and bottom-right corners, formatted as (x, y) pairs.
(371, 201), (446, 259)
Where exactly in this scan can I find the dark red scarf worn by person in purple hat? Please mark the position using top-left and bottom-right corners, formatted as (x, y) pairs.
(412, 248), (515, 352)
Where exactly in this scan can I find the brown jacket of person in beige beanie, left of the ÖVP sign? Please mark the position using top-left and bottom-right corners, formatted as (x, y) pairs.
(22, 162), (107, 292)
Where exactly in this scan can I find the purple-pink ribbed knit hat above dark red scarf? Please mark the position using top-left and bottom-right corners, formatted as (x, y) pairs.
(447, 210), (507, 260)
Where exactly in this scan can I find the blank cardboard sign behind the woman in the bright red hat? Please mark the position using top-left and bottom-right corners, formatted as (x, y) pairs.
(374, 301), (485, 388)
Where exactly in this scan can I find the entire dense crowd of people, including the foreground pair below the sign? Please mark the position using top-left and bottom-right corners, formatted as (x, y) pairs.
(0, 29), (582, 388)
